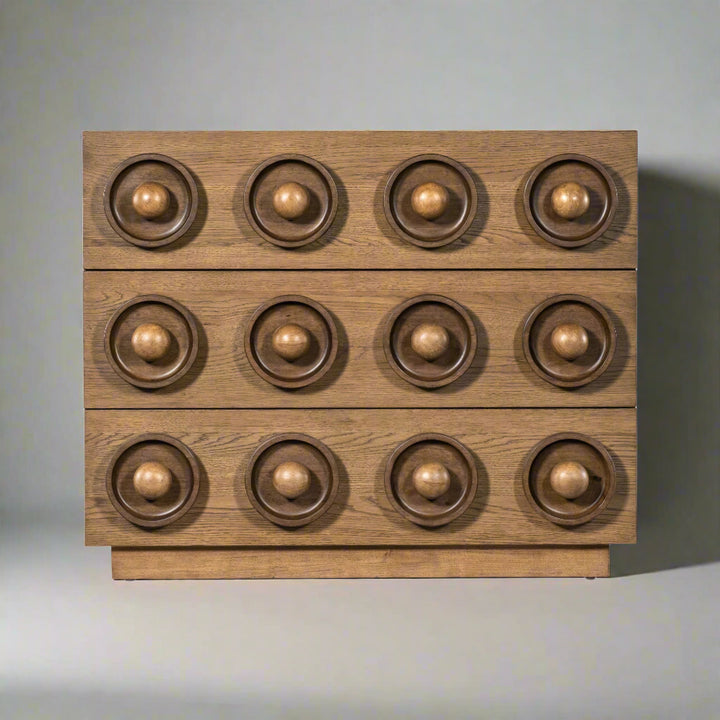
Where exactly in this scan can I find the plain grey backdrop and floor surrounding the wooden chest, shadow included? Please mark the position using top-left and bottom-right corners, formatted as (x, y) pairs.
(0, 0), (720, 718)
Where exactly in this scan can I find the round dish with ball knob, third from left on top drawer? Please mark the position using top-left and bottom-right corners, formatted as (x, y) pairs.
(383, 154), (477, 248)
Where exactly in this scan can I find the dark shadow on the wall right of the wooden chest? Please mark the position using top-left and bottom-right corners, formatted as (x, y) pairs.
(611, 169), (720, 575)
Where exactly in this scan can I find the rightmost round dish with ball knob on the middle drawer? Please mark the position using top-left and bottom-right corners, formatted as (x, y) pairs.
(523, 295), (617, 388)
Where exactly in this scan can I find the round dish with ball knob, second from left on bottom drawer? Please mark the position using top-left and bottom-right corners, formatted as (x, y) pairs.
(245, 433), (339, 527)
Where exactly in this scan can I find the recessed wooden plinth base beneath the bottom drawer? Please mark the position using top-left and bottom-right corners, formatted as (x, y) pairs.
(112, 546), (610, 580)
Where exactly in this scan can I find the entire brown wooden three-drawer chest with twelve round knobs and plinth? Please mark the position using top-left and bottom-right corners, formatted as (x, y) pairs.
(83, 132), (637, 579)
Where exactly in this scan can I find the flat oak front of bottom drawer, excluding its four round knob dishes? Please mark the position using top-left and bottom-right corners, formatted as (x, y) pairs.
(85, 409), (636, 547)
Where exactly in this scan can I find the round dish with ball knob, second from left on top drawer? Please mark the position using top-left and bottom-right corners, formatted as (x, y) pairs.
(244, 154), (338, 248)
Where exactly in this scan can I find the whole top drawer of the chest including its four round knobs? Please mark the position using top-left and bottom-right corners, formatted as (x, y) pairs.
(83, 131), (637, 269)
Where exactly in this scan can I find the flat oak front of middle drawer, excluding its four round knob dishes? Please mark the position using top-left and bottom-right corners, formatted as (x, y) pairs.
(85, 270), (636, 408)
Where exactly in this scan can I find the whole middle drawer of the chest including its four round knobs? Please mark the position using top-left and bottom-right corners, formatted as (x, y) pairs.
(85, 270), (636, 408)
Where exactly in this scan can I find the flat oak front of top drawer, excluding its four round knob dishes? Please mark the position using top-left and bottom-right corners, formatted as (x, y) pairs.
(83, 131), (637, 269)
